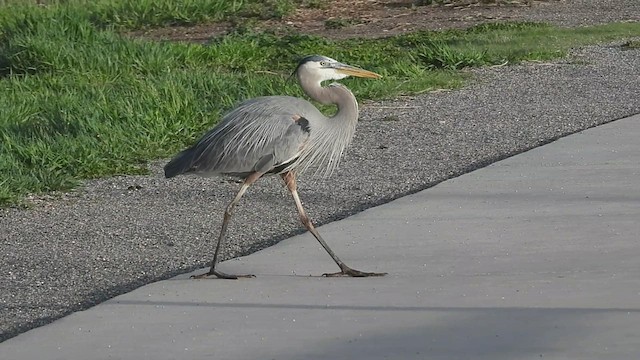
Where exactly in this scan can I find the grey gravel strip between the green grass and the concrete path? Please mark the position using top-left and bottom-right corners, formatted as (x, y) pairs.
(0, 4), (640, 341)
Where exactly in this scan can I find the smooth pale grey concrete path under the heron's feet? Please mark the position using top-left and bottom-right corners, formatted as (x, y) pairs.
(0, 115), (640, 360)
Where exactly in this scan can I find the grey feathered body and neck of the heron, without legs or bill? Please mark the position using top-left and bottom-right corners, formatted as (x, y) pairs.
(165, 55), (358, 178)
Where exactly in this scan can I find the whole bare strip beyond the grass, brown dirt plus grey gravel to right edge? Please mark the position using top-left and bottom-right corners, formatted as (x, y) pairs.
(127, 0), (640, 42)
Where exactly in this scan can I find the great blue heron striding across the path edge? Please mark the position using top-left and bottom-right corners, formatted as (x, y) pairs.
(164, 55), (385, 279)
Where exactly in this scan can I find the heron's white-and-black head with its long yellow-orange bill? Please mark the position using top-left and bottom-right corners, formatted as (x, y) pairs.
(294, 55), (382, 82)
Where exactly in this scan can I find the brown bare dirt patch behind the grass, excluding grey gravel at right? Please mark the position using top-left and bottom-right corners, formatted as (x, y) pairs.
(132, 0), (533, 42)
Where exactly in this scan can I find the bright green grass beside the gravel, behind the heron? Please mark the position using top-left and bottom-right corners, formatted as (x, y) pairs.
(0, 0), (640, 206)
